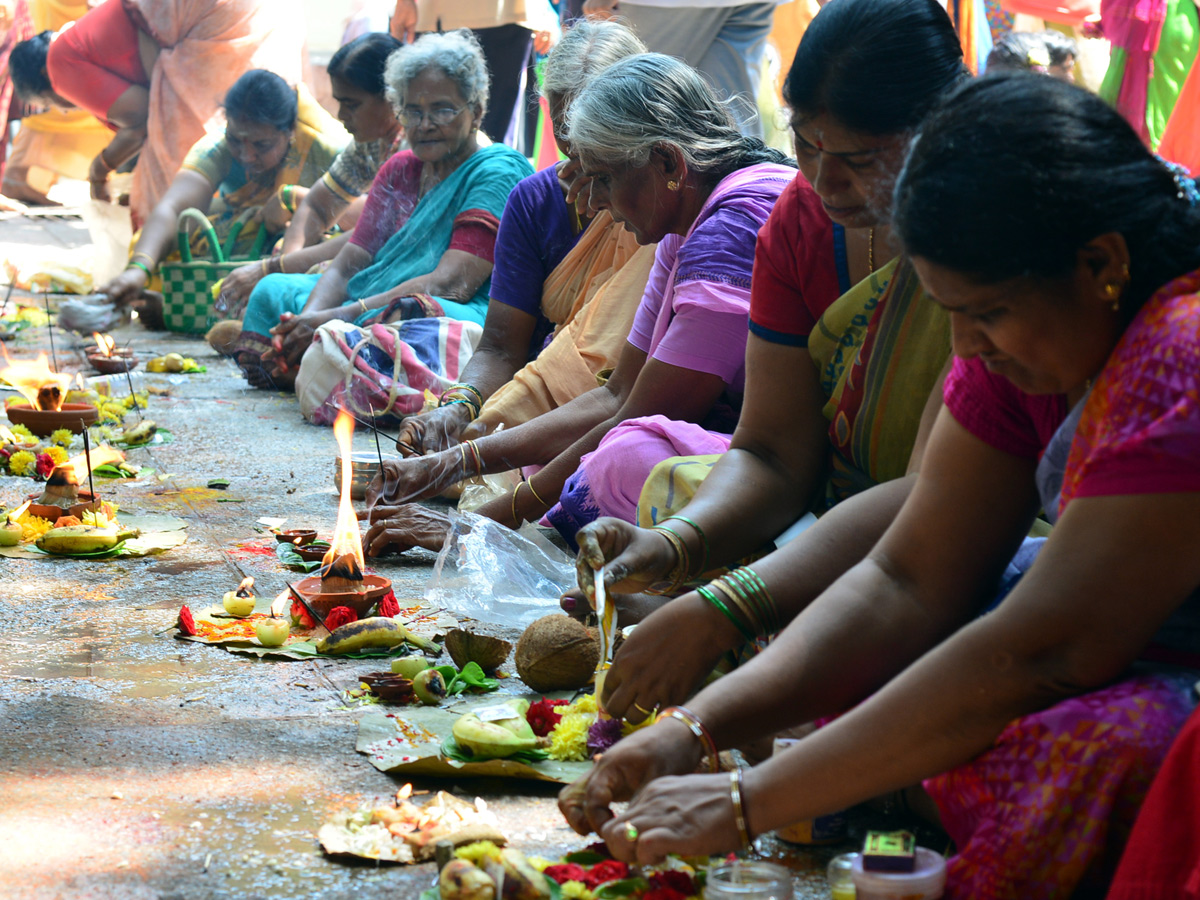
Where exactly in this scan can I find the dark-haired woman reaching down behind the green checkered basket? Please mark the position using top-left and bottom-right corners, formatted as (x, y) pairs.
(100, 68), (347, 314)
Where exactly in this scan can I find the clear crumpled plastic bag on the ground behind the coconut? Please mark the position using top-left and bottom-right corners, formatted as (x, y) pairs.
(425, 512), (575, 629)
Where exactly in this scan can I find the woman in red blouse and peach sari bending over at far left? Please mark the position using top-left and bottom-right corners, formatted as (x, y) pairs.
(12, 0), (304, 227)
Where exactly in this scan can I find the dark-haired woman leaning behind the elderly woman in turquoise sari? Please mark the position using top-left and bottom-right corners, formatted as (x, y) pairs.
(216, 32), (403, 321)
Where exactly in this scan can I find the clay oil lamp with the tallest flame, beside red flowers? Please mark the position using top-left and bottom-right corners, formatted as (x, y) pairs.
(295, 412), (391, 618)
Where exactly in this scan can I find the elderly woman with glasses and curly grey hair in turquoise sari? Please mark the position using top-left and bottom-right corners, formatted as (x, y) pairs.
(235, 31), (532, 391)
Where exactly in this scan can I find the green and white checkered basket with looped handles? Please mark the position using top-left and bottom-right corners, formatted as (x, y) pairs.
(158, 209), (268, 335)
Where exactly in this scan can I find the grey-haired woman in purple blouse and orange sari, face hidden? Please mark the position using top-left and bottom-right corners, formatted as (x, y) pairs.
(381, 19), (654, 454)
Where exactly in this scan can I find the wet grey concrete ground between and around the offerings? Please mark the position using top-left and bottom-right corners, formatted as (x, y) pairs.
(0, 218), (873, 900)
